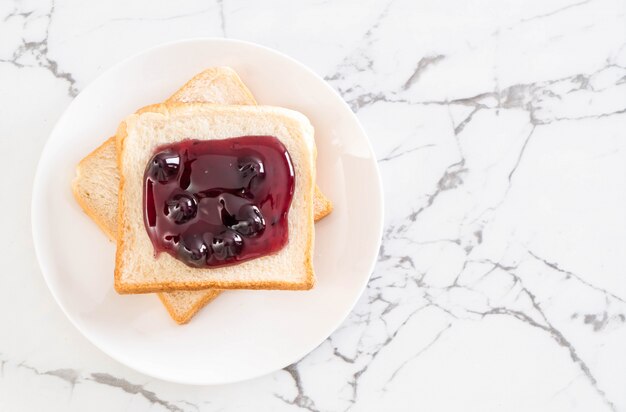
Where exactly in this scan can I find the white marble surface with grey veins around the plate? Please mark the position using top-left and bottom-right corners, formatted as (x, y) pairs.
(0, 0), (626, 411)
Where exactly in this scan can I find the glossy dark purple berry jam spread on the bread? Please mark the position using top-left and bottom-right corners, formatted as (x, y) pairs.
(143, 136), (295, 267)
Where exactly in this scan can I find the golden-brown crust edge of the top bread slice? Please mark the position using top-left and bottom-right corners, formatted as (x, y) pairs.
(114, 103), (315, 294)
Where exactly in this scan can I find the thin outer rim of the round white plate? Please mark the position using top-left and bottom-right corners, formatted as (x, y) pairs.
(30, 37), (385, 386)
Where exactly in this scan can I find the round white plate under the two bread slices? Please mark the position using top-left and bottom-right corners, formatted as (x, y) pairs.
(32, 39), (383, 384)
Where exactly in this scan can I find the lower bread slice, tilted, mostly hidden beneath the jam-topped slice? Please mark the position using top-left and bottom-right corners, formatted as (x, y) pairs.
(72, 67), (332, 324)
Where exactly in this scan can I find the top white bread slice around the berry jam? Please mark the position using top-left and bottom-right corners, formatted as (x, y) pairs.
(115, 103), (315, 293)
